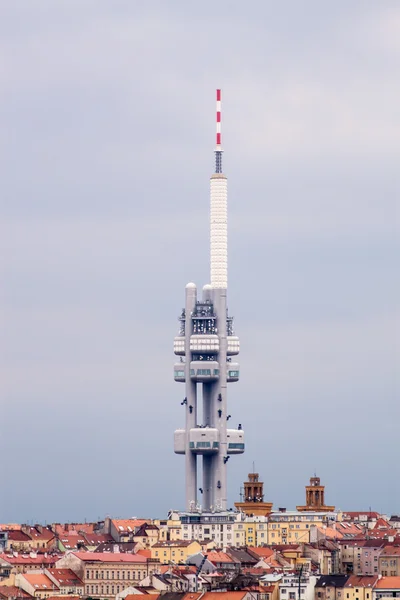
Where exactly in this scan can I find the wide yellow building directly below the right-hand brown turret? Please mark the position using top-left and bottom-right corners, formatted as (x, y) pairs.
(267, 510), (336, 545)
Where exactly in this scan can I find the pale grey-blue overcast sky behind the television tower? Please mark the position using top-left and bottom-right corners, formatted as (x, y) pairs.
(0, 0), (400, 522)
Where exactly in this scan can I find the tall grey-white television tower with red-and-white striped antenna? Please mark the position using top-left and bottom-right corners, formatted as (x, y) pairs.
(174, 90), (244, 512)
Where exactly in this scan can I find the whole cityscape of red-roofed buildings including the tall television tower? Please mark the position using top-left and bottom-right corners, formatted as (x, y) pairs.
(0, 89), (400, 600)
